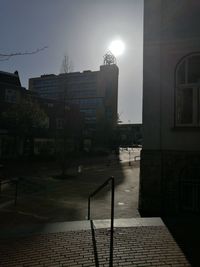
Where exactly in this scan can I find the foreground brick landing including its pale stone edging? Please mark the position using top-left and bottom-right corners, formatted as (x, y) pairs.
(0, 218), (191, 267)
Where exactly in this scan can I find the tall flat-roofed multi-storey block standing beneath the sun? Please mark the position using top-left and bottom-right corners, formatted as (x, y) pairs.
(29, 64), (119, 149)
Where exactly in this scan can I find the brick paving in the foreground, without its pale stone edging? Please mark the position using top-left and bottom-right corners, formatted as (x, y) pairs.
(0, 226), (190, 267)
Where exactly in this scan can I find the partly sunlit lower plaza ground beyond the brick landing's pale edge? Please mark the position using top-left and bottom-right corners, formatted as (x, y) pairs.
(0, 153), (139, 227)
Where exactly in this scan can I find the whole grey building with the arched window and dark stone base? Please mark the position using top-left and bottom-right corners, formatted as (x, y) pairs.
(139, 0), (200, 215)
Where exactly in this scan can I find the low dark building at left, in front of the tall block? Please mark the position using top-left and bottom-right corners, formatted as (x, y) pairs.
(0, 71), (83, 159)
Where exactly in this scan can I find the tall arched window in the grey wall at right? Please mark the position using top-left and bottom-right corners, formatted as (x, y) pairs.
(175, 53), (200, 127)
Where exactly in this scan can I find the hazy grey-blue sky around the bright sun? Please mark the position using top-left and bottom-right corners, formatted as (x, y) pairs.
(0, 0), (143, 123)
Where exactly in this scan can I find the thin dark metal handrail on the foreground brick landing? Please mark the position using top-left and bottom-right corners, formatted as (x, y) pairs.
(88, 177), (115, 267)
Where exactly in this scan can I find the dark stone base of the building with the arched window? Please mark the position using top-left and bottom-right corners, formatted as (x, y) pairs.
(139, 150), (200, 215)
